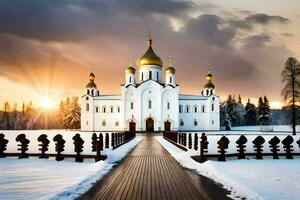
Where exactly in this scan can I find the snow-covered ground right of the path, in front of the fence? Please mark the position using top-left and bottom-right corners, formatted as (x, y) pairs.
(156, 136), (300, 200)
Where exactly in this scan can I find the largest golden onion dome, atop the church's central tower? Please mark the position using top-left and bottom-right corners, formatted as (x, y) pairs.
(137, 37), (163, 67)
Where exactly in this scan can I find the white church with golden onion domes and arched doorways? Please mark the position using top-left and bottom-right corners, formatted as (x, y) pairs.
(81, 36), (220, 132)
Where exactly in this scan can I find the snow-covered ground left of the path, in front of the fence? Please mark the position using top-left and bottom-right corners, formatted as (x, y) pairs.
(0, 137), (142, 200)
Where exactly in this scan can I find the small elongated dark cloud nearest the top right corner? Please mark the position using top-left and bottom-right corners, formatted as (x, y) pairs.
(245, 13), (289, 25)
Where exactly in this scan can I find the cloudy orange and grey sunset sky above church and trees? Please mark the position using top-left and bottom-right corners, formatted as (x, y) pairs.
(0, 0), (300, 107)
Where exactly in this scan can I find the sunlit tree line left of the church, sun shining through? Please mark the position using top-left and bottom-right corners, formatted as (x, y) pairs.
(0, 96), (80, 130)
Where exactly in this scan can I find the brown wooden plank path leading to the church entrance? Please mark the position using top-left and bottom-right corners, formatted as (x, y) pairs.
(81, 136), (227, 200)
